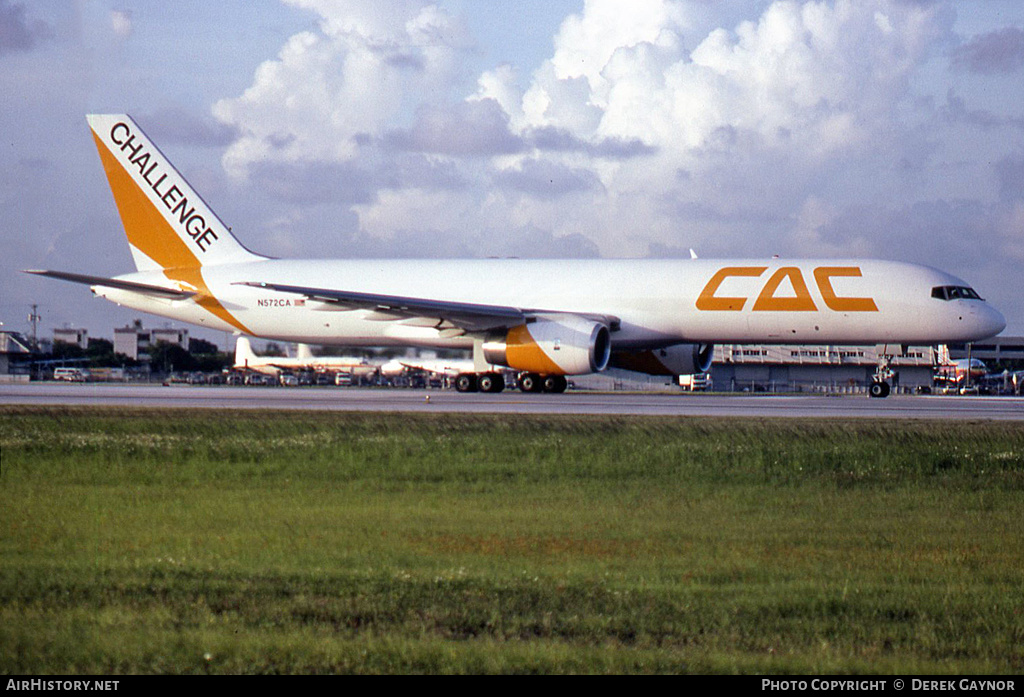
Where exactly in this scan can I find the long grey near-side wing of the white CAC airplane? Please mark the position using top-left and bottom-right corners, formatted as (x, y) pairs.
(237, 281), (620, 332)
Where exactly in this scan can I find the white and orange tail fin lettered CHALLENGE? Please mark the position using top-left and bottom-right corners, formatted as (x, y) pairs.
(86, 114), (264, 271)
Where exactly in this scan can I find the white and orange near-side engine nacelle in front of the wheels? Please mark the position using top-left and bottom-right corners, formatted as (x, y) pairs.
(483, 315), (611, 376)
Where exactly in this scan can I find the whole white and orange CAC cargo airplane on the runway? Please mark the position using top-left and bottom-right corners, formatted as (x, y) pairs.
(24, 115), (1006, 396)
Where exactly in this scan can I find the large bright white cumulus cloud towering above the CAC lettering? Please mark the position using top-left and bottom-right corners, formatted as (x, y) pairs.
(468, 0), (949, 254)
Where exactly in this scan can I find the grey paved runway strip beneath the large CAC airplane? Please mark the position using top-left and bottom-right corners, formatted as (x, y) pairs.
(0, 383), (1024, 422)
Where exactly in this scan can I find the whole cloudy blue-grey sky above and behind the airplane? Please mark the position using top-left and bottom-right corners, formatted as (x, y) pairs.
(0, 0), (1024, 339)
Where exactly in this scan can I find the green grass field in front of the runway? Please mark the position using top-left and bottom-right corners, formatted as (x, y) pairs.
(0, 407), (1024, 673)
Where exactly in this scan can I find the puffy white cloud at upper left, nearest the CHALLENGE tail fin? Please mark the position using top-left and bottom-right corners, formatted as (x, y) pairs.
(213, 0), (467, 177)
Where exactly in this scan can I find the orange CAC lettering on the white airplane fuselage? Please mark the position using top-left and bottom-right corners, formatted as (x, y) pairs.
(696, 266), (879, 312)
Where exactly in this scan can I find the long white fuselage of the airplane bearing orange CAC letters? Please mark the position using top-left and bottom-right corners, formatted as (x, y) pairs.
(94, 259), (1005, 348)
